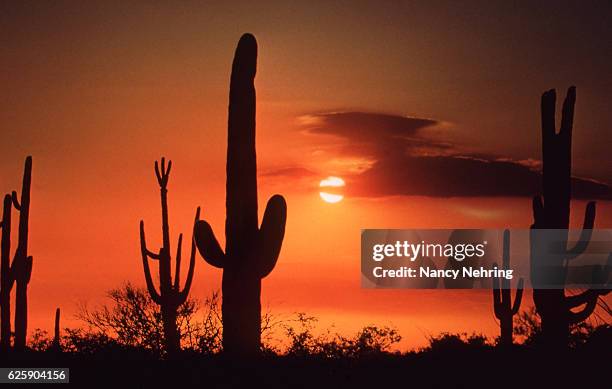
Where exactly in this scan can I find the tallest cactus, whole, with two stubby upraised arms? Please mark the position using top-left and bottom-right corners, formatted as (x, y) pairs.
(195, 34), (287, 356)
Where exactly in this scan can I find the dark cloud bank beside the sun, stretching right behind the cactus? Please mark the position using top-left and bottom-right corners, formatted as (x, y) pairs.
(294, 112), (612, 199)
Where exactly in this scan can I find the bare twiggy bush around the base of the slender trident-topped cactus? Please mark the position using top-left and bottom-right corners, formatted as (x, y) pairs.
(29, 283), (222, 356)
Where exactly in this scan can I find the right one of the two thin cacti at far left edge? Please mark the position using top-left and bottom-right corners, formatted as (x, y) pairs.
(10, 156), (32, 350)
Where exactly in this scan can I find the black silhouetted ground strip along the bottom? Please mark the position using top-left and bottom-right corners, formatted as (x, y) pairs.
(2, 327), (612, 388)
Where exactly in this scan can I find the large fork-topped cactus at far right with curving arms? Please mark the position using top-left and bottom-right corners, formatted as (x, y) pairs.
(530, 87), (609, 347)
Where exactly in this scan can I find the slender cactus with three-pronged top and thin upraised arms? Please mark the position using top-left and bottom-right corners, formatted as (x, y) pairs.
(140, 158), (200, 354)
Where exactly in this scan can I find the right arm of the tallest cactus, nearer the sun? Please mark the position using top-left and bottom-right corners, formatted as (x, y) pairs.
(257, 195), (287, 278)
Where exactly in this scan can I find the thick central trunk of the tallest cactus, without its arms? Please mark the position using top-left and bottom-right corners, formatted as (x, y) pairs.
(222, 33), (261, 354)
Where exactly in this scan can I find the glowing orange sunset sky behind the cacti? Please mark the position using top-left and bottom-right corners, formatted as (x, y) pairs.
(0, 1), (612, 347)
